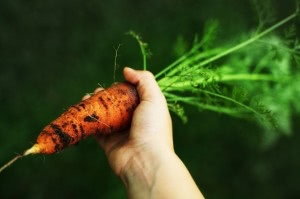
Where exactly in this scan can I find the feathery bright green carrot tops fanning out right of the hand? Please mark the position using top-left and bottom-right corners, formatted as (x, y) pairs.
(150, 9), (300, 146)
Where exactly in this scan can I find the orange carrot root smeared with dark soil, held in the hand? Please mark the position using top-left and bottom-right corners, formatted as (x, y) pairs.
(36, 82), (140, 154)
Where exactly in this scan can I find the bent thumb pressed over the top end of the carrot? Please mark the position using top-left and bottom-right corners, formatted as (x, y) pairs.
(123, 67), (165, 102)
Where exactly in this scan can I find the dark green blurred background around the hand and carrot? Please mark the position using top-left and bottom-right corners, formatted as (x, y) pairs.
(0, 0), (300, 199)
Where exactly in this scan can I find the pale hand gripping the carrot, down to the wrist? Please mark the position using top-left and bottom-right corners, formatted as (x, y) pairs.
(92, 68), (173, 178)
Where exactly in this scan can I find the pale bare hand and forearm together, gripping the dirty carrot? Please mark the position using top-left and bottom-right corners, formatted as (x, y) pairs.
(83, 67), (204, 199)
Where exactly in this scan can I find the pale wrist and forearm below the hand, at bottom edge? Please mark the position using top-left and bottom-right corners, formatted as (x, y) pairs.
(122, 149), (203, 199)
